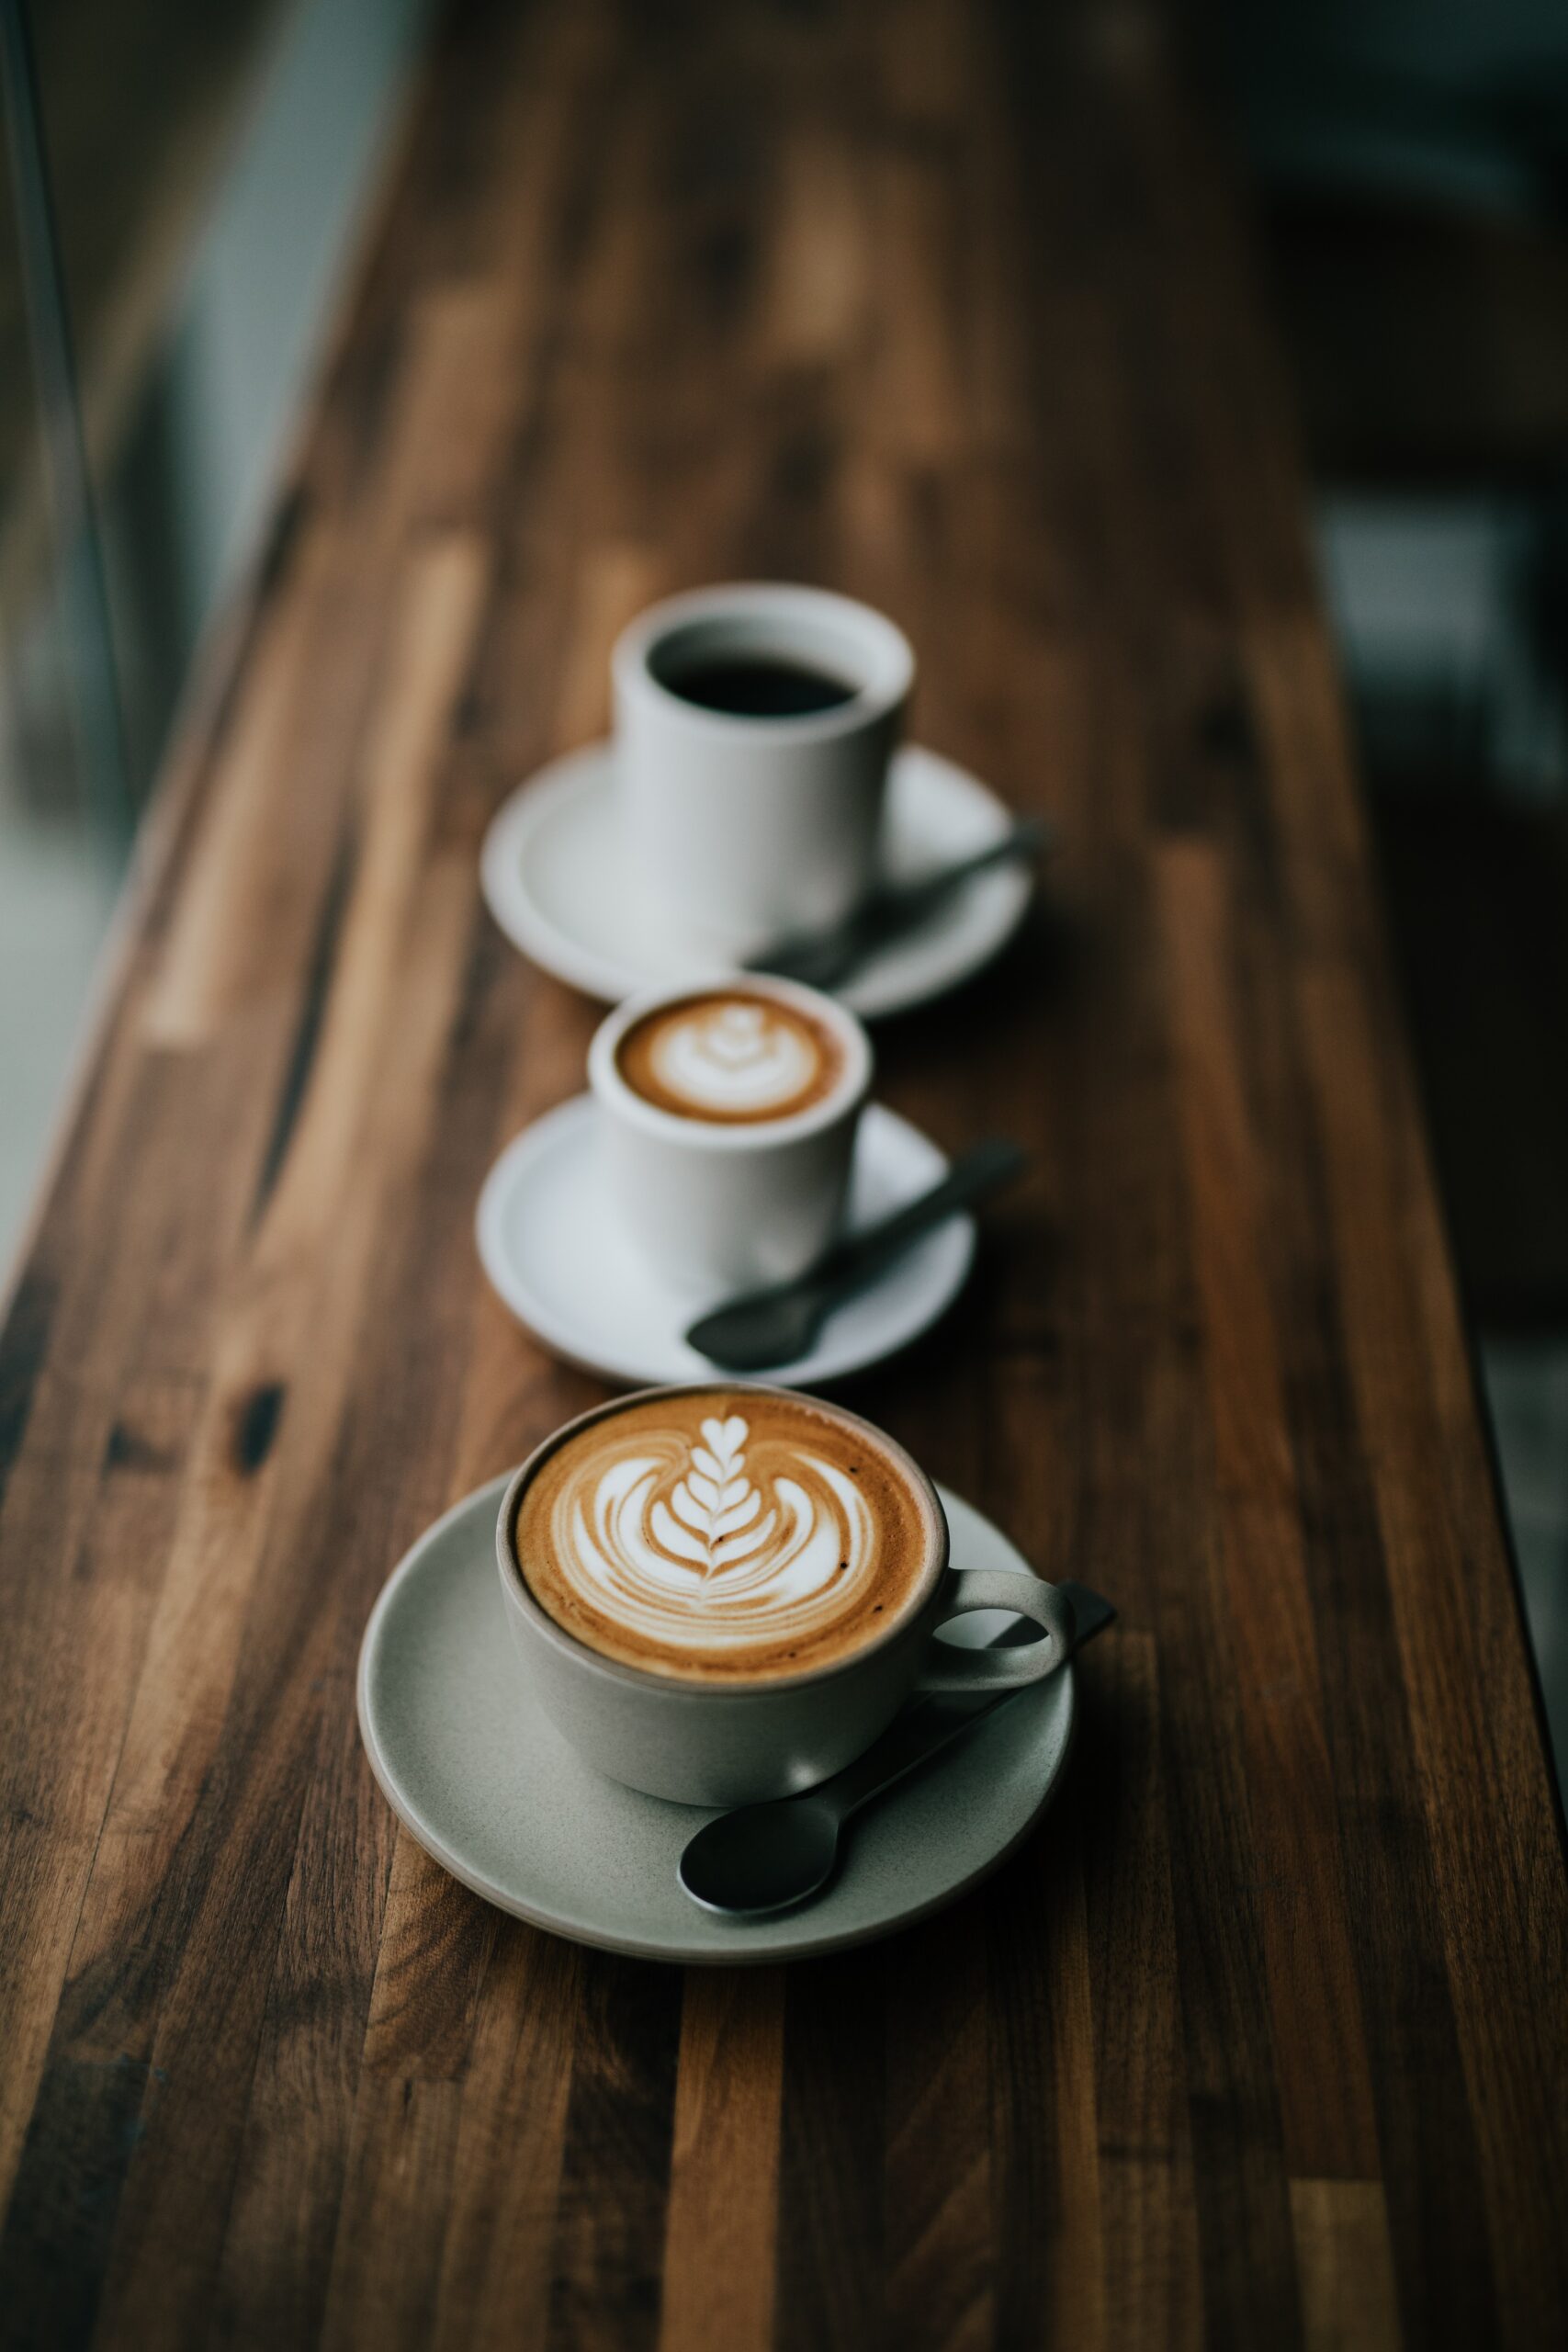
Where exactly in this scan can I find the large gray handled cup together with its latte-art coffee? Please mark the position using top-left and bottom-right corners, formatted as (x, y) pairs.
(496, 1381), (1072, 1806)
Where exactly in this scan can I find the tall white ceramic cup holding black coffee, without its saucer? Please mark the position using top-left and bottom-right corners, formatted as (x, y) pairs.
(611, 583), (915, 957)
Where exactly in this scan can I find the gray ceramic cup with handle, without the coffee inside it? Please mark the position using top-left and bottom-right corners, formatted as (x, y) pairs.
(496, 1381), (1072, 1806)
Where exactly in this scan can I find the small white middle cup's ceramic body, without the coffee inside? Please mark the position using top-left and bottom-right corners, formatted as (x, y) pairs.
(588, 974), (872, 1294)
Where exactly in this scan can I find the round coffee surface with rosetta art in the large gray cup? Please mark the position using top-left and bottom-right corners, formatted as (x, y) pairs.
(513, 1387), (945, 1681)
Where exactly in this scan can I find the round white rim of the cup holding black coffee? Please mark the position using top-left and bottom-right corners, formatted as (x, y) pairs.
(609, 581), (915, 742)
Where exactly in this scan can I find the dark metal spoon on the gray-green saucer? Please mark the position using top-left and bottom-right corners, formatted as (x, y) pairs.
(680, 1578), (1117, 1919)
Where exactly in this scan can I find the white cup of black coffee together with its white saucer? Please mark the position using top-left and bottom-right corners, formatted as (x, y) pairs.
(479, 581), (1032, 1018)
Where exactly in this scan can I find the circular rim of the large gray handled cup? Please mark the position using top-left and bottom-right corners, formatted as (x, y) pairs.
(496, 1378), (952, 1705)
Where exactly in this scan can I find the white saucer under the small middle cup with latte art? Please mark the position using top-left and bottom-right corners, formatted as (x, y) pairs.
(475, 1093), (976, 1387)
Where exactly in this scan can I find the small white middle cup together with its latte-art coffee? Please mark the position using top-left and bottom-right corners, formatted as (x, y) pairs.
(588, 974), (872, 1294)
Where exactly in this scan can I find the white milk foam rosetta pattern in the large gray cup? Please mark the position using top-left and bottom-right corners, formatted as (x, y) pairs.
(552, 1414), (877, 1656)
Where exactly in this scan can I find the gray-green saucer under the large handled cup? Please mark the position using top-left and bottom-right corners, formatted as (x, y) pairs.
(360, 1477), (1075, 1966)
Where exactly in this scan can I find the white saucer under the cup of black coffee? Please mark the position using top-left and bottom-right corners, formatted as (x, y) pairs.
(479, 743), (1032, 1018)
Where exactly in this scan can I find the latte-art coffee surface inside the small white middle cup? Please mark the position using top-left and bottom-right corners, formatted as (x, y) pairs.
(616, 988), (844, 1126)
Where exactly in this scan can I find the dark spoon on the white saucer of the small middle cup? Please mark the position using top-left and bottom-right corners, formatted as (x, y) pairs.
(686, 1141), (1027, 1371)
